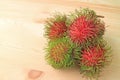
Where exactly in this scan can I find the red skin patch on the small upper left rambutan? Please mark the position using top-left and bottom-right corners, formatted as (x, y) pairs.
(48, 21), (67, 39)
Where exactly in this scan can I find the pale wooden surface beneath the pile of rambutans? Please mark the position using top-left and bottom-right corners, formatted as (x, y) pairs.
(0, 0), (120, 80)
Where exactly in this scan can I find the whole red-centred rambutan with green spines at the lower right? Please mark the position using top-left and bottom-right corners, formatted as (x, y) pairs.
(78, 42), (111, 78)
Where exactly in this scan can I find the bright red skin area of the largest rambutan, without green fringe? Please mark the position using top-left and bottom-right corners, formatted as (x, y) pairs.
(69, 16), (104, 44)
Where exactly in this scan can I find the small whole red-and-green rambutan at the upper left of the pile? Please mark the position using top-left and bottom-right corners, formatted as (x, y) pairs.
(45, 14), (67, 40)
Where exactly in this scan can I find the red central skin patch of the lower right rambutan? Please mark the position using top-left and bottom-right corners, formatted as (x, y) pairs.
(81, 46), (105, 66)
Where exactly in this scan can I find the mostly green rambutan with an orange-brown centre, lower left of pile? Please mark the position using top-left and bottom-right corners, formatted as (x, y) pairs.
(46, 37), (74, 68)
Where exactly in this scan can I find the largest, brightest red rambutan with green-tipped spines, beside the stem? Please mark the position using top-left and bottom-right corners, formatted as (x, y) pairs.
(68, 9), (105, 44)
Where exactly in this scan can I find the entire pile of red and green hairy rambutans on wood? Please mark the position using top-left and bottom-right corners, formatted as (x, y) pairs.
(45, 8), (111, 79)
